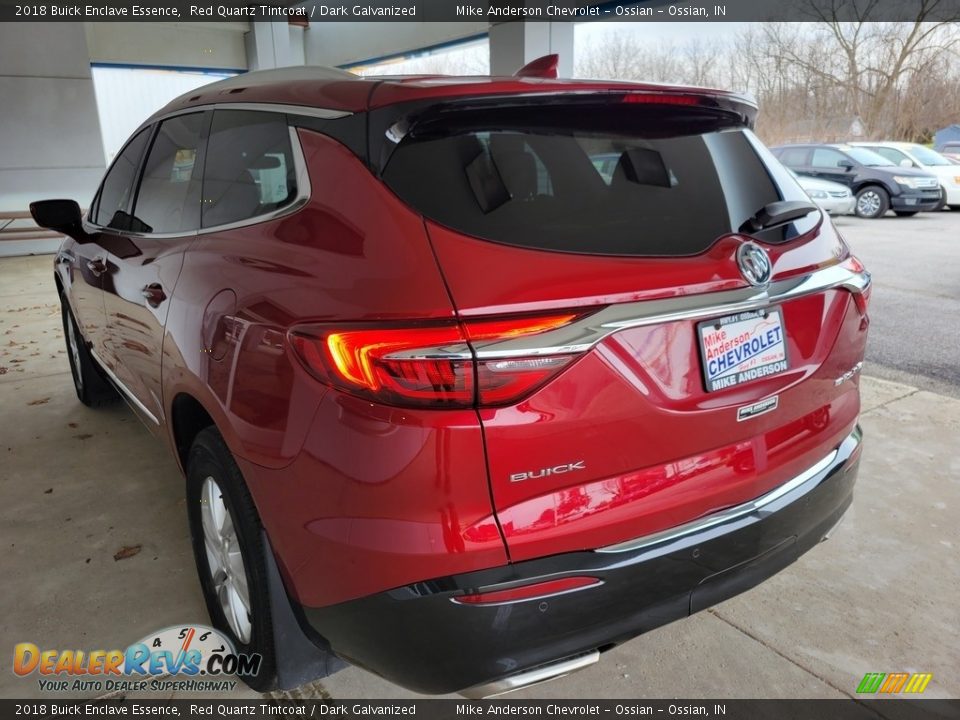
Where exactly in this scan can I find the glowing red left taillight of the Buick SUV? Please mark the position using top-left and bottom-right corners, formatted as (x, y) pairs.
(290, 313), (581, 408)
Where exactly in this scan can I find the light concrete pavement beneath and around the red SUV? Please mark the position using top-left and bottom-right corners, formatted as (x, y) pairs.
(0, 256), (960, 698)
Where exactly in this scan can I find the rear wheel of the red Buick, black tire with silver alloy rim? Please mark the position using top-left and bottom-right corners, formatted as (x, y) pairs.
(187, 426), (276, 692)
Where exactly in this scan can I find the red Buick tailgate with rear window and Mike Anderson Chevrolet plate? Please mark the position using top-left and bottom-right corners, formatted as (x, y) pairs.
(383, 100), (865, 559)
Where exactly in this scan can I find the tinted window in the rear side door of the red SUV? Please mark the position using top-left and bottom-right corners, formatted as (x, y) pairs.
(130, 113), (203, 233)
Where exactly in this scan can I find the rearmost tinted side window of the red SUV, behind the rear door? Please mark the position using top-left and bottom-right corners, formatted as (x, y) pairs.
(202, 110), (297, 227)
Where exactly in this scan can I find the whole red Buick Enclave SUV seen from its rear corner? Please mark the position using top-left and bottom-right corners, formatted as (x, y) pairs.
(32, 63), (870, 696)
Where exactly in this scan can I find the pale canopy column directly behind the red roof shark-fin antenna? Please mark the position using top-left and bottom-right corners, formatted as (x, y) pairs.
(490, 22), (574, 77)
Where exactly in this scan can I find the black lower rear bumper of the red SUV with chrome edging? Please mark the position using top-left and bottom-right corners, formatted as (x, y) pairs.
(302, 428), (861, 693)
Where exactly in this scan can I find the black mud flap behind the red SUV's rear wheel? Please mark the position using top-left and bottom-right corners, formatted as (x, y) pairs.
(262, 532), (347, 690)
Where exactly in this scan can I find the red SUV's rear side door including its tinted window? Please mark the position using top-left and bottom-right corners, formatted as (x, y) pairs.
(104, 112), (210, 428)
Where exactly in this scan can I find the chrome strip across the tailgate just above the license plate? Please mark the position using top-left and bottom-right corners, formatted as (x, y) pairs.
(474, 264), (870, 360)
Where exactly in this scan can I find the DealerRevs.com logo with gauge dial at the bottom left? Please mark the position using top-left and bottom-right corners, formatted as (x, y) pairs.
(13, 625), (263, 692)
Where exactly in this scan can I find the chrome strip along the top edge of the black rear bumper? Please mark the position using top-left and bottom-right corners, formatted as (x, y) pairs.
(594, 427), (862, 553)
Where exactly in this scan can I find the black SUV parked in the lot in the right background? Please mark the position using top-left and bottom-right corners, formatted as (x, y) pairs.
(771, 144), (942, 218)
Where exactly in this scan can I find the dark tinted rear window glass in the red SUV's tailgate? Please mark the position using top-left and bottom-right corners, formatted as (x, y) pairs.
(383, 108), (819, 256)
